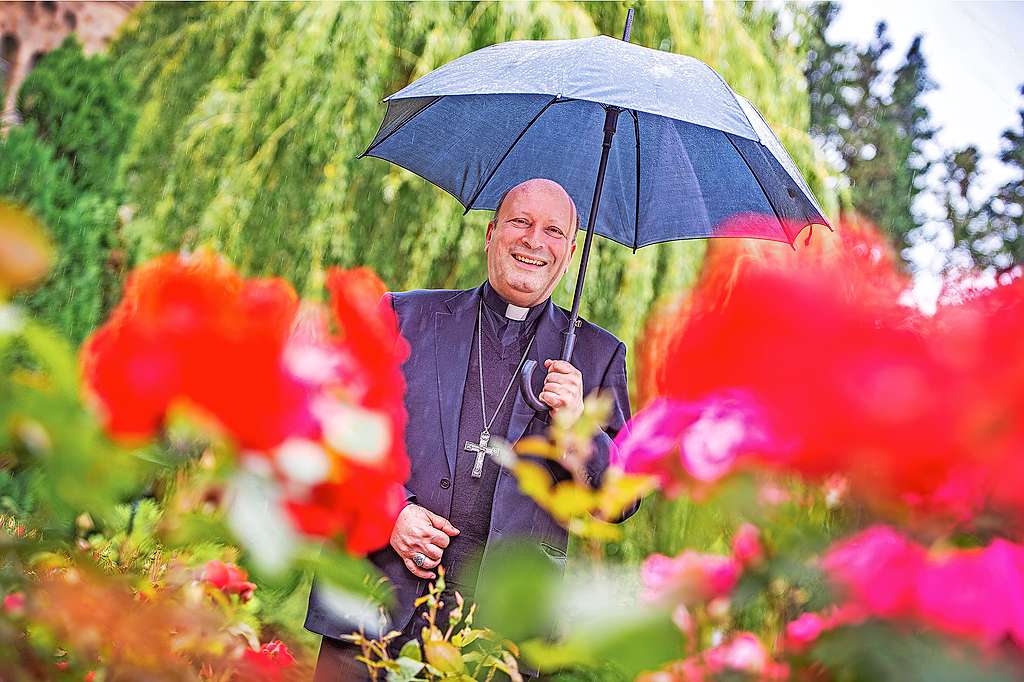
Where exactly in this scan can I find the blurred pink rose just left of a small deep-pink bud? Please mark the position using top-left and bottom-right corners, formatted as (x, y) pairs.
(641, 550), (739, 605)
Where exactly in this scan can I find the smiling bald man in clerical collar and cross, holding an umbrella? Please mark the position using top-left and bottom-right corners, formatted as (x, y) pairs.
(306, 179), (630, 682)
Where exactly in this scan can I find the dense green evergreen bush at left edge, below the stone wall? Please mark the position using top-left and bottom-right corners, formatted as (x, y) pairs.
(0, 38), (134, 345)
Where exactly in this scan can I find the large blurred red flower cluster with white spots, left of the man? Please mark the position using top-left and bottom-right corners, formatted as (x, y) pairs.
(82, 251), (409, 564)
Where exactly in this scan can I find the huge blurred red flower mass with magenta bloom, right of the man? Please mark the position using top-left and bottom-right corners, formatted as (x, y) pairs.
(620, 220), (1024, 523)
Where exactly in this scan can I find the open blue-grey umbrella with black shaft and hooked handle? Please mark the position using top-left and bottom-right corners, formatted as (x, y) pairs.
(362, 9), (828, 412)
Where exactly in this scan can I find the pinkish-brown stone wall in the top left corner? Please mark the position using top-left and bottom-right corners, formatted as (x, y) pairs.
(0, 0), (139, 128)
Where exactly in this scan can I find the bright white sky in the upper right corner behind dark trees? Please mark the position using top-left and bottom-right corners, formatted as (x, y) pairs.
(828, 0), (1024, 310)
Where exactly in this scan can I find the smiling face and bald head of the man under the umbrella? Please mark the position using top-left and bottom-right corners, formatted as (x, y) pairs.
(484, 179), (577, 308)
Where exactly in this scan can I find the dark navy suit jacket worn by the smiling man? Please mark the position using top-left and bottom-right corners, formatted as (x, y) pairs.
(305, 288), (630, 637)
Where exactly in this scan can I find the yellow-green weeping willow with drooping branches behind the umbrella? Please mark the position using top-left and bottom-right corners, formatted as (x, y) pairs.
(115, 2), (824, 360)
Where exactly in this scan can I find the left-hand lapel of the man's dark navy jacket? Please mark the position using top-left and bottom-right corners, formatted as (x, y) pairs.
(434, 289), (479, 475)
